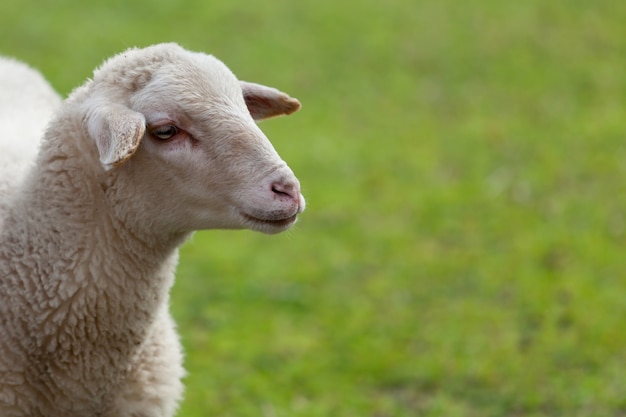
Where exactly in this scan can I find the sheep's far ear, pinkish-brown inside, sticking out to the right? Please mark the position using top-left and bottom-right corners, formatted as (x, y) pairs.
(240, 81), (301, 120)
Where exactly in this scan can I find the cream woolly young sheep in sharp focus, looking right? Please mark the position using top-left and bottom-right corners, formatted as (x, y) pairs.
(0, 43), (305, 417)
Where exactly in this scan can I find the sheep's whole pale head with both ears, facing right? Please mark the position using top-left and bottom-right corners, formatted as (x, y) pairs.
(86, 45), (305, 237)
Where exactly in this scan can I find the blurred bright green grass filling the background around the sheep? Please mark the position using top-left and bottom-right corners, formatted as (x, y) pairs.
(0, 0), (626, 417)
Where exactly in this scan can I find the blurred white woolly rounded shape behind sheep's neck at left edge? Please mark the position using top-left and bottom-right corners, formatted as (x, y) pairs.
(0, 57), (61, 219)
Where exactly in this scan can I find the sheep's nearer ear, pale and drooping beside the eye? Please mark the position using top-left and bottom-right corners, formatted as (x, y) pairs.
(87, 104), (146, 171)
